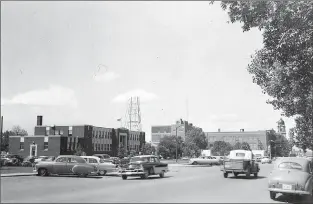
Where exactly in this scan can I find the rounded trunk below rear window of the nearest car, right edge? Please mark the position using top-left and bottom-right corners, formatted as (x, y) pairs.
(269, 170), (311, 185)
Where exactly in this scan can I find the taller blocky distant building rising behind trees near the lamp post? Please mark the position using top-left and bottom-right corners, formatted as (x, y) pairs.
(151, 120), (192, 146)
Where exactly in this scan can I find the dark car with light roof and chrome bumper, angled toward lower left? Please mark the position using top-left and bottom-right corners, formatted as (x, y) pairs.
(120, 155), (168, 180)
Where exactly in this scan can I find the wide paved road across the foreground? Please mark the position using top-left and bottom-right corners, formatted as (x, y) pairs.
(1, 164), (312, 203)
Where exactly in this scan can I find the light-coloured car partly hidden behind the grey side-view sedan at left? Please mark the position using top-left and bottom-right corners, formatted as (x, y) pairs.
(81, 156), (117, 176)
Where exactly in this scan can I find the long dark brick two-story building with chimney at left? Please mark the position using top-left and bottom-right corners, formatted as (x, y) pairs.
(9, 116), (145, 156)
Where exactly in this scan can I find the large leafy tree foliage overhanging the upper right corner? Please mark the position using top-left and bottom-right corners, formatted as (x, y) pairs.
(214, 1), (313, 149)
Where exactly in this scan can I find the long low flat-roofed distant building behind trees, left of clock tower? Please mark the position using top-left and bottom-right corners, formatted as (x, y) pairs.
(204, 129), (268, 150)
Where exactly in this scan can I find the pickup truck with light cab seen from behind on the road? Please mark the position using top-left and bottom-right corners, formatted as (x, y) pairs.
(221, 150), (260, 178)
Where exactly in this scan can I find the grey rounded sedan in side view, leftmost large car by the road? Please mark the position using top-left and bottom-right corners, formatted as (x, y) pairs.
(34, 155), (98, 177)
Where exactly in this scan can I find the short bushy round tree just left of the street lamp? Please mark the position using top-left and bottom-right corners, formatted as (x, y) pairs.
(158, 136), (183, 158)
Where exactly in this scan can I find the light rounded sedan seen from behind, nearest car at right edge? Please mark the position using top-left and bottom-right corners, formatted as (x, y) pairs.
(268, 157), (313, 200)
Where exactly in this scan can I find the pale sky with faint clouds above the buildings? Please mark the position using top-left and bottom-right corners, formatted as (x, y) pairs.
(1, 1), (294, 141)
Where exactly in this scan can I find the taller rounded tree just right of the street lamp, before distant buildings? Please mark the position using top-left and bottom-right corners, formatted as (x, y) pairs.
(183, 127), (208, 157)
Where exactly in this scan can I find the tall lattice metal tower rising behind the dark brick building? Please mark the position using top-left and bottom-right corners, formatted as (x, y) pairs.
(124, 97), (141, 131)
